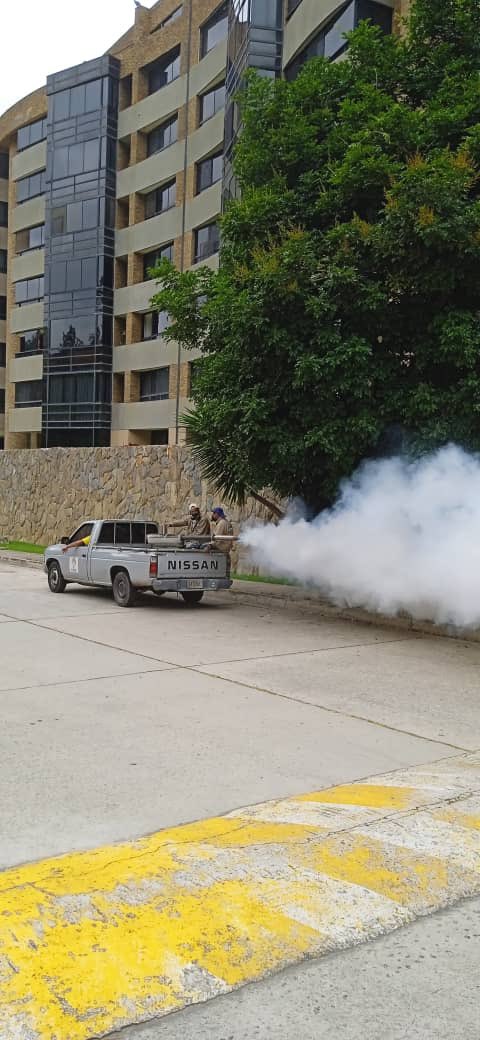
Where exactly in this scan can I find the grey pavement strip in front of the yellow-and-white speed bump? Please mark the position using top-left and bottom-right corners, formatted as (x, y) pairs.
(115, 900), (480, 1040)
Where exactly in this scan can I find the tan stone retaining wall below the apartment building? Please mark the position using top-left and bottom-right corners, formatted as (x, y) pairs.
(0, 446), (272, 572)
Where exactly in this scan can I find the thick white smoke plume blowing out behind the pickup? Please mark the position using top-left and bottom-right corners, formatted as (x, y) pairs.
(241, 445), (480, 627)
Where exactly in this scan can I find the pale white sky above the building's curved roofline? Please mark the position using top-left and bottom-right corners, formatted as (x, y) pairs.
(0, 0), (154, 114)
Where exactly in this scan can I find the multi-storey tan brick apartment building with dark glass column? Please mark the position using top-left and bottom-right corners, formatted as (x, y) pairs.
(0, 0), (400, 448)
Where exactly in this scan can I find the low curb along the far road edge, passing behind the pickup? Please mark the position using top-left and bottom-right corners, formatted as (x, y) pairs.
(0, 549), (480, 643)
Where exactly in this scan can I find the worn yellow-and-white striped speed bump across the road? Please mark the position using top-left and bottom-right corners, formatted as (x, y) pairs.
(0, 755), (480, 1040)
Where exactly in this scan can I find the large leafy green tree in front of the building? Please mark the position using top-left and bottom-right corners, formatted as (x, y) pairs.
(151, 0), (480, 510)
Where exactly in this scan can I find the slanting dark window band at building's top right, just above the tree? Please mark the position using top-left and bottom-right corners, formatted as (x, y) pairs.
(286, 0), (393, 80)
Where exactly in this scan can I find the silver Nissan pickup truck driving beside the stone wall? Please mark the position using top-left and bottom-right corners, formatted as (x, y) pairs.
(45, 520), (232, 606)
